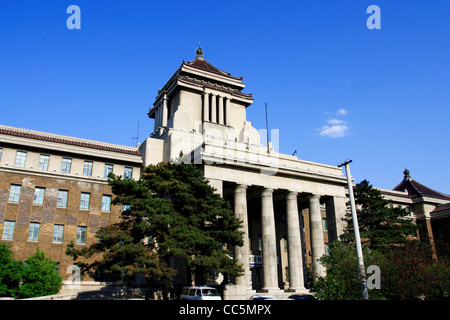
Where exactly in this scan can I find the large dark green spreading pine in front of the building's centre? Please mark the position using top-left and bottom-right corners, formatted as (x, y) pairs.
(67, 163), (242, 288)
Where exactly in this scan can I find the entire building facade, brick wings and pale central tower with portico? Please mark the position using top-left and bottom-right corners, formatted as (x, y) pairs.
(0, 47), (450, 299)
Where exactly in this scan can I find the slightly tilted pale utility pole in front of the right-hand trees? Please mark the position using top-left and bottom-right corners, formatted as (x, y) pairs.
(338, 159), (369, 300)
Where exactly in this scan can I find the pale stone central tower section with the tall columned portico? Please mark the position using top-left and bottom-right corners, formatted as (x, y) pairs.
(139, 47), (346, 299)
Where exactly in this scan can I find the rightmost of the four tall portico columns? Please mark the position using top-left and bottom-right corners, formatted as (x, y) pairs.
(309, 194), (325, 279)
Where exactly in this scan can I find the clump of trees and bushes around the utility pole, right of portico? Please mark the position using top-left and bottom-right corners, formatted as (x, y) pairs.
(312, 180), (450, 300)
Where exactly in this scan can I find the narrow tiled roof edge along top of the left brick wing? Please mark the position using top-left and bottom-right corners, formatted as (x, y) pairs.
(0, 127), (140, 156)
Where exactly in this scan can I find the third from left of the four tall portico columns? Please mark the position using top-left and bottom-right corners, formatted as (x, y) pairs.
(286, 192), (305, 290)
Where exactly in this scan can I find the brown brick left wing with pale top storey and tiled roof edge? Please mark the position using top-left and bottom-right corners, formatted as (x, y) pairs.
(0, 125), (142, 279)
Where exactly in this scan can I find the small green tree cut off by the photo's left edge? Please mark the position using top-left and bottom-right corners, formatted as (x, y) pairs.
(0, 242), (23, 297)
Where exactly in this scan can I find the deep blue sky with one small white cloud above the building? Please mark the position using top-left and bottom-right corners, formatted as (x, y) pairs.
(0, 0), (450, 194)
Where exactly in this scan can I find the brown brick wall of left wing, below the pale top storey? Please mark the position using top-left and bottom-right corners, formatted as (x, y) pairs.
(0, 172), (122, 279)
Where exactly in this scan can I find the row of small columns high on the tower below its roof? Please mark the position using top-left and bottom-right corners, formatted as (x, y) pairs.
(203, 92), (230, 125)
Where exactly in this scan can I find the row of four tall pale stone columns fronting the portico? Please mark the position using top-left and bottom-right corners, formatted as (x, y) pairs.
(234, 185), (325, 291)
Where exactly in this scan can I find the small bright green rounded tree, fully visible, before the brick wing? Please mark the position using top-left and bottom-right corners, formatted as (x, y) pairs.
(16, 248), (62, 298)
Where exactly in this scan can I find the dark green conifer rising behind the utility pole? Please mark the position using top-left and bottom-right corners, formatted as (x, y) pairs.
(341, 180), (417, 250)
